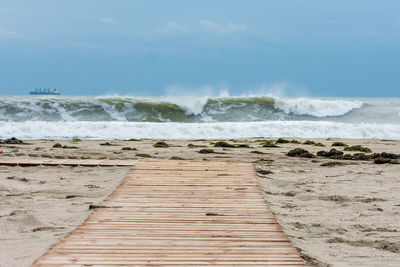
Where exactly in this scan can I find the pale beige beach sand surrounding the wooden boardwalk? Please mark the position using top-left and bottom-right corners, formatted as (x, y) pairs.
(0, 139), (400, 267)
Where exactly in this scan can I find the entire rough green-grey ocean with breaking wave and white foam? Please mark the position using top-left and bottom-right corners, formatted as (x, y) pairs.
(0, 95), (400, 140)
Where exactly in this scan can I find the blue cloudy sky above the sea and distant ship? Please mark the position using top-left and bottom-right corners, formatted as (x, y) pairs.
(0, 0), (400, 97)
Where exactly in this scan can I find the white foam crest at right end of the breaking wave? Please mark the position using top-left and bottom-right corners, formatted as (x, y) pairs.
(274, 98), (363, 117)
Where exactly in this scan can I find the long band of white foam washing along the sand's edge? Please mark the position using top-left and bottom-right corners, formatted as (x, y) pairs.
(0, 121), (400, 140)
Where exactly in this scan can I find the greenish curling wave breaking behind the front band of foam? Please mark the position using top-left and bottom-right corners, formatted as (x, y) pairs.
(0, 96), (364, 122)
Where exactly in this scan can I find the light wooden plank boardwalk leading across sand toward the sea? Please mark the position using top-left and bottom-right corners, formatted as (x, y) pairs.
(33, 160), (304, 267)
